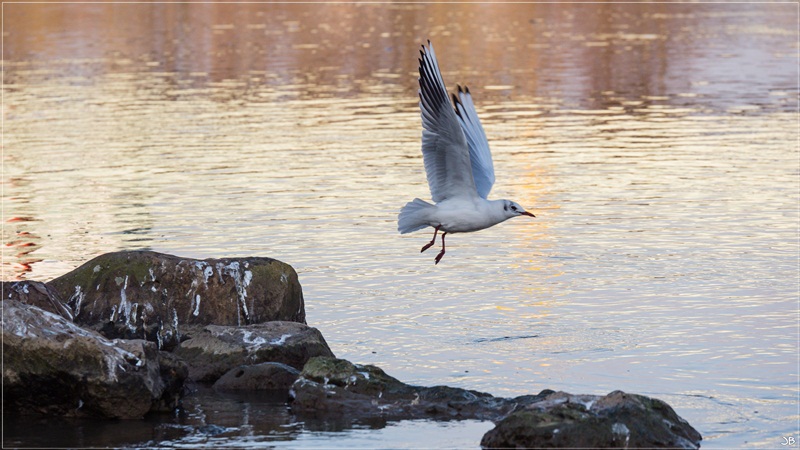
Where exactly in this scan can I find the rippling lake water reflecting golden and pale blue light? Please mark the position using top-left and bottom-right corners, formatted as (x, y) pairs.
(2, 4), (800, 448)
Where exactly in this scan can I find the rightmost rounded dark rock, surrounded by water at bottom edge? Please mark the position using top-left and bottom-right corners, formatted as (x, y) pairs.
(481, 391), (702, 449)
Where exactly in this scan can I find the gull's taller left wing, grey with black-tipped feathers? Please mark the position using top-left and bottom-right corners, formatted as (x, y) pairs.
(419, 41), (478, 203)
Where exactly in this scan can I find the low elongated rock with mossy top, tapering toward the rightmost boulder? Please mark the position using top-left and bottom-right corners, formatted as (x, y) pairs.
(291, 357), (517, 420)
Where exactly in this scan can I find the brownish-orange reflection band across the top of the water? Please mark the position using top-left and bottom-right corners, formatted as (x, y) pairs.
(5, 4), (797, 109)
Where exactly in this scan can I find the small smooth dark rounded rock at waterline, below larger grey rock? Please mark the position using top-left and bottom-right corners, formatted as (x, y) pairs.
(214, 362), (300, 391)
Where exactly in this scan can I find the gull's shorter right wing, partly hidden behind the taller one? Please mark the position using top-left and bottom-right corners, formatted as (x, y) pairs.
(453, 86), (494, 198)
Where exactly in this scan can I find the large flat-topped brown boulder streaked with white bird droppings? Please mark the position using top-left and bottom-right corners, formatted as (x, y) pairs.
(49, 251), (305, 349)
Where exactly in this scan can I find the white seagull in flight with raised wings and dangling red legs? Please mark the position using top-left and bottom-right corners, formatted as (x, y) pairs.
(397, 41), (536, 264)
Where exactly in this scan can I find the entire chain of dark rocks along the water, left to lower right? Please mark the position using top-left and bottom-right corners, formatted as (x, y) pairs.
(2, 251), (702, 448)
